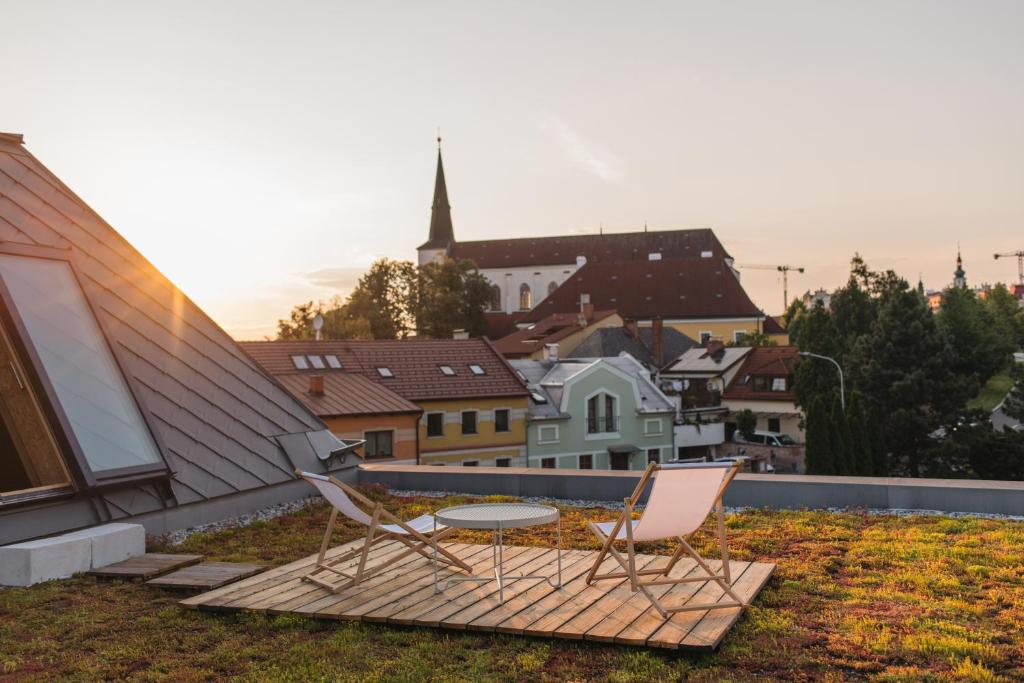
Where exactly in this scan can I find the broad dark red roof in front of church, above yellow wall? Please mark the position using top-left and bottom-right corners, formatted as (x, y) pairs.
(521, 258), (764, 322)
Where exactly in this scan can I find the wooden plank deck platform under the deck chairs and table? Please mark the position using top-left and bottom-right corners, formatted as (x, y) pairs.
(181, 542), (775, 650)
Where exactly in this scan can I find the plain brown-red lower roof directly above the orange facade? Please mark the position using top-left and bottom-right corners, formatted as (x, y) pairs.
(278, 371), (423, 418)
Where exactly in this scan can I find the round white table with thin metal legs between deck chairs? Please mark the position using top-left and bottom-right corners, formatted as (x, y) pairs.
(434, 503), (562, 603)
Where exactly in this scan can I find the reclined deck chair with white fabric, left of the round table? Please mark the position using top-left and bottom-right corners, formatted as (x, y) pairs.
(295, 470), (472, 593)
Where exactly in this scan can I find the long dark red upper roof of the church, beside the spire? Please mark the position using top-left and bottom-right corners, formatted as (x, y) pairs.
(451, 228), (729, 268)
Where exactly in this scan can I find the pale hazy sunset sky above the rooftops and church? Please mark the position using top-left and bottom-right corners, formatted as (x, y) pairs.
(0, 0), (1024, 339)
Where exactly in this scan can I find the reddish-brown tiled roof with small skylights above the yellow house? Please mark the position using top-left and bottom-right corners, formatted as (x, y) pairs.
(241, 339), (526, 401)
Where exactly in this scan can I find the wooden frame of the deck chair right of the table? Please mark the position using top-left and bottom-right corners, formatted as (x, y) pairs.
(586, 463), (746, 618)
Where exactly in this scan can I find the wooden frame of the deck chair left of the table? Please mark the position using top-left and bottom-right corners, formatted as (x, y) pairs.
(295, 470), (472, 593)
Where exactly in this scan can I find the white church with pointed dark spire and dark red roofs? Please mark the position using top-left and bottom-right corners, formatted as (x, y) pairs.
(418, 138), (781, 341)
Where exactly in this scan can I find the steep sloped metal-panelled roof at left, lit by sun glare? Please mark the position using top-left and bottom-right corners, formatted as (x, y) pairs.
(0, 134), (337, 517)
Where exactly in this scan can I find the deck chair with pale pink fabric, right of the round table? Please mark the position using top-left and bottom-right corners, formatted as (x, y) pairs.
(587, 462), (746, 618)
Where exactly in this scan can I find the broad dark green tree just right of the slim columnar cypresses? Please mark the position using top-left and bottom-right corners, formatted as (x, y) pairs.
(850, 282), (971, 476)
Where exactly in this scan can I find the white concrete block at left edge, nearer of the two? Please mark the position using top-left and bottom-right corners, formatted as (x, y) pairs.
(0, 537), (92, 586)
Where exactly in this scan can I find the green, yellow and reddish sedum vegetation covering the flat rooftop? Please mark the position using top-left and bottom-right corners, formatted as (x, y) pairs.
(0, 487), (1024, 681)
